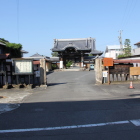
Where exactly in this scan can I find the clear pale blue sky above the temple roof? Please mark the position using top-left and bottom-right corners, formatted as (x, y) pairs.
(0, 0), (140, 57)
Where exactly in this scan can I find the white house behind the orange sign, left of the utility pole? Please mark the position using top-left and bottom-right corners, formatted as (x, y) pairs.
(105, 45), (124, 59)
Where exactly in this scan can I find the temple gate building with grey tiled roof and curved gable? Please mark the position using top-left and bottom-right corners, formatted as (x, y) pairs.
(52, 38), (103, 68)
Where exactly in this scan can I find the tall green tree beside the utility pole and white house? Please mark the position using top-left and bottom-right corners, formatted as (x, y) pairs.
(118, 39), (131, 58)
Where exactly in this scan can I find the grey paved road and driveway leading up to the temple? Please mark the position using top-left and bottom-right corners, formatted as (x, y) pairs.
(0, 71), (140, 140)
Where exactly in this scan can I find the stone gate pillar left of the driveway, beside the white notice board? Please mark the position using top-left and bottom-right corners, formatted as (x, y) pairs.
(40, 59), (47, 87)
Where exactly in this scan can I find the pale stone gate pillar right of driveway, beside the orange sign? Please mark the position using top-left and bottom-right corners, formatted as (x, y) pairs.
(94, 58), (103, 84)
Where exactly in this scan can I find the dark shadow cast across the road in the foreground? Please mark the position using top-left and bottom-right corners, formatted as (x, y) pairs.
(0, 98), (140, 140)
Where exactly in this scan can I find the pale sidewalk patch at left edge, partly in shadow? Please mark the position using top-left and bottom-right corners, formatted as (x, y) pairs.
(0, 88), (32, 114)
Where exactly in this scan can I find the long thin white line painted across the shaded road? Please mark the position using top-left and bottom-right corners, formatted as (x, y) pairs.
(0, 121), (130, 133)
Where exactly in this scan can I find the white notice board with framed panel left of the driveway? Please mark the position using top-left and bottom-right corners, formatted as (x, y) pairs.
(14, 59), (33, 74)
